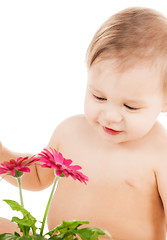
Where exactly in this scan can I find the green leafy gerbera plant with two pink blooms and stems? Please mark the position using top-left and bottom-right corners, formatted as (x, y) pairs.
(0, 148), (110, 240)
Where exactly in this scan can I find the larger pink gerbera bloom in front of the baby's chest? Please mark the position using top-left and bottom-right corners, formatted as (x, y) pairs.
(39, 148), (88, 184)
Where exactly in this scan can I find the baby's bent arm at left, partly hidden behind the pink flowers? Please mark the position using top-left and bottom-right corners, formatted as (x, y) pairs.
(0, 116), (79, 191)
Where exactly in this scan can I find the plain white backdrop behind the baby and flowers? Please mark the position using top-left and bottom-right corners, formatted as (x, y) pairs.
(0, 0), (167, 233)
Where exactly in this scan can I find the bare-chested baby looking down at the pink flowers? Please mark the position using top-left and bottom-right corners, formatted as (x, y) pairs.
(0, 8), (167, 240)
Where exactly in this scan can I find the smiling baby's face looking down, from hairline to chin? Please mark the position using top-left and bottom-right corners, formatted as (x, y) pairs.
(85, 60), (164, 143)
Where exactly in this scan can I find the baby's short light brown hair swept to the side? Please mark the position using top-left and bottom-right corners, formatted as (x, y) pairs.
(86, 7), (167, 73)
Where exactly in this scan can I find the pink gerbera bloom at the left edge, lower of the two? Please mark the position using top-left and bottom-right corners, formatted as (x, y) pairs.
(0, 156), (39, 176)
